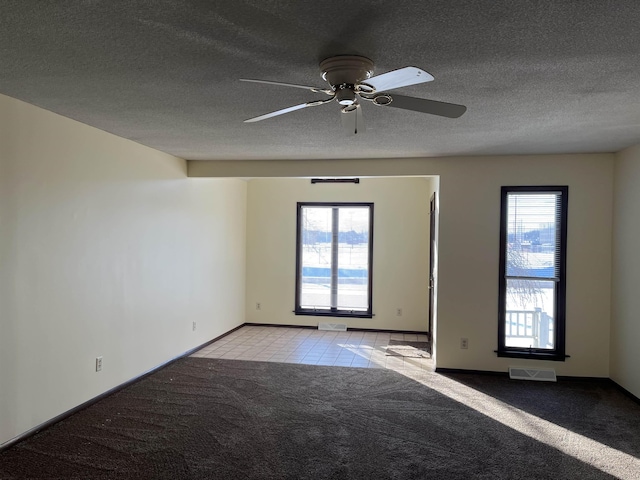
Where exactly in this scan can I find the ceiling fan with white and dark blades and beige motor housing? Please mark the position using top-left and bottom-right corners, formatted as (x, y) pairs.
(240, 55), (467, 134)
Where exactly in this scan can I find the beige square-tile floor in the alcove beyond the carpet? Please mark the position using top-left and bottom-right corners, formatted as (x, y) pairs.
(192, 326), (433, 371)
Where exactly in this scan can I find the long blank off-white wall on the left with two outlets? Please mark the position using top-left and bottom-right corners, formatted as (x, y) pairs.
(0, 96), (246, 444)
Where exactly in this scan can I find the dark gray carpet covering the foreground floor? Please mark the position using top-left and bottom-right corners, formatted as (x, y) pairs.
(0, 358), (640, 480)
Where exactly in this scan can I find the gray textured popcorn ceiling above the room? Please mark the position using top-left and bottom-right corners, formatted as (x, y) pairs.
(0, 0), (640, 160)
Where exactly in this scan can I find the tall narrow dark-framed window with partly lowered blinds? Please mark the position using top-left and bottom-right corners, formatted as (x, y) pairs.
(497, 187), (568, 360)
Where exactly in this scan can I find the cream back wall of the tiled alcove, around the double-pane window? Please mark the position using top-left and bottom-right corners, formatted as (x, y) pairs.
(246, 177), (434, 331)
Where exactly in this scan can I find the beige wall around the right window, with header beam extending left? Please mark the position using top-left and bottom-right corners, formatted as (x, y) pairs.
(188, 154), (614, 377)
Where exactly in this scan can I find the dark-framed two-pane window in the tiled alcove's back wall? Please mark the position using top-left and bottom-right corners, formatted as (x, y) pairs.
(295, 203), (373, 318)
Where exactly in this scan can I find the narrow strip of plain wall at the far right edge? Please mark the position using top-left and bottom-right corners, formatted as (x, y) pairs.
(611, 145), (640, 397)
